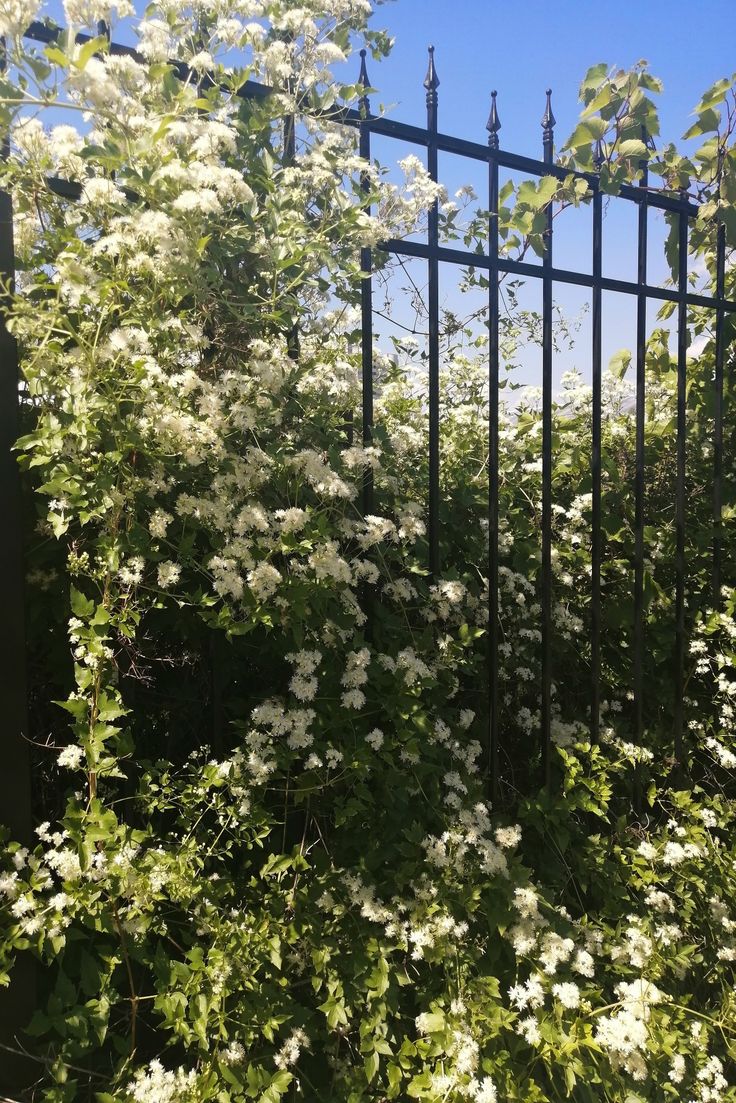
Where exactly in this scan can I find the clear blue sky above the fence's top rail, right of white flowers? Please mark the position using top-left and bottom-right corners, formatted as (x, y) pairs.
(370, 0), (736, 156)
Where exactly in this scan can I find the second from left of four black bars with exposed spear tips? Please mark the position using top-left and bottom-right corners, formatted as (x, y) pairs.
(424, 46), (439, 579)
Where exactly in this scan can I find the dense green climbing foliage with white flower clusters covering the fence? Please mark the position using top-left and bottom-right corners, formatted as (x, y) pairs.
(0, 0), (736, 1103)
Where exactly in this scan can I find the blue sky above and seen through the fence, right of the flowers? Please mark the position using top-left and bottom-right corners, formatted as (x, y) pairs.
(355, 0), (736, 383)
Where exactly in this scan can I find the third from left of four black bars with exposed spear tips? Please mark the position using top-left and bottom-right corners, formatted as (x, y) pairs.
(486, 92), (501, 801)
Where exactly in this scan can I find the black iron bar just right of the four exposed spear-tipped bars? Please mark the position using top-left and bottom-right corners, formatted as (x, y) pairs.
(590, 142), (602, 743)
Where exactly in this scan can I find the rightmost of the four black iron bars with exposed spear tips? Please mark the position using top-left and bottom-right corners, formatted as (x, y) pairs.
(541, 88), (555, 786)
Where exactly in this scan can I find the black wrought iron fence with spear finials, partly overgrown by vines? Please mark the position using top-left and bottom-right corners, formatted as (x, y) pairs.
(0, 30), (736, 838)
